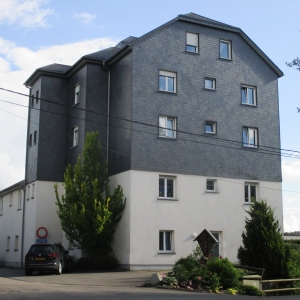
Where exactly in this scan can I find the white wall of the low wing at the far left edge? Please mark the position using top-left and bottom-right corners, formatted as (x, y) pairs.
(0, 189), (24, 268)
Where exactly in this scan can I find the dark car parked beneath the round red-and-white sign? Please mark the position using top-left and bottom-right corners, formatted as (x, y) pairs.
(25, 244), (72, 275)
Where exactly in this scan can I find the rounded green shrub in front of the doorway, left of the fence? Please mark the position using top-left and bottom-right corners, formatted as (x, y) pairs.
(207, 258), (239, 289)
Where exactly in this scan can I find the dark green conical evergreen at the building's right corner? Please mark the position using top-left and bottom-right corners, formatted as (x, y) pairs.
(237, 200), (289, 279)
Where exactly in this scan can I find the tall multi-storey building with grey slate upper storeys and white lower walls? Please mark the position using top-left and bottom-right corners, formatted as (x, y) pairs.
(0, 13), (283, 269)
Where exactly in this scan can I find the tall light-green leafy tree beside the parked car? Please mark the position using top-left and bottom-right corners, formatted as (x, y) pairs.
(54, 132), (126, 256)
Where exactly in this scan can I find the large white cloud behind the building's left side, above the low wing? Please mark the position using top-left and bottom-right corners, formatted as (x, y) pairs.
(0, 35), (118, 190)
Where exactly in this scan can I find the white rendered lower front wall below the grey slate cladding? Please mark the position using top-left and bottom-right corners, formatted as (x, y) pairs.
(111, 171), (283, 269)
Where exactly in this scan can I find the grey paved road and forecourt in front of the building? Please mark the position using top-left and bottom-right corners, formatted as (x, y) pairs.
(0, 268), (299, 300)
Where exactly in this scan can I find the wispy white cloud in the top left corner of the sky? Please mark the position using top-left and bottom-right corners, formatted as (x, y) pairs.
(0, 0), (53, 28)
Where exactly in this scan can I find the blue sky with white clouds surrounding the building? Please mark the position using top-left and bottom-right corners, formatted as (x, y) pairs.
(0, 0), (300, 232)
